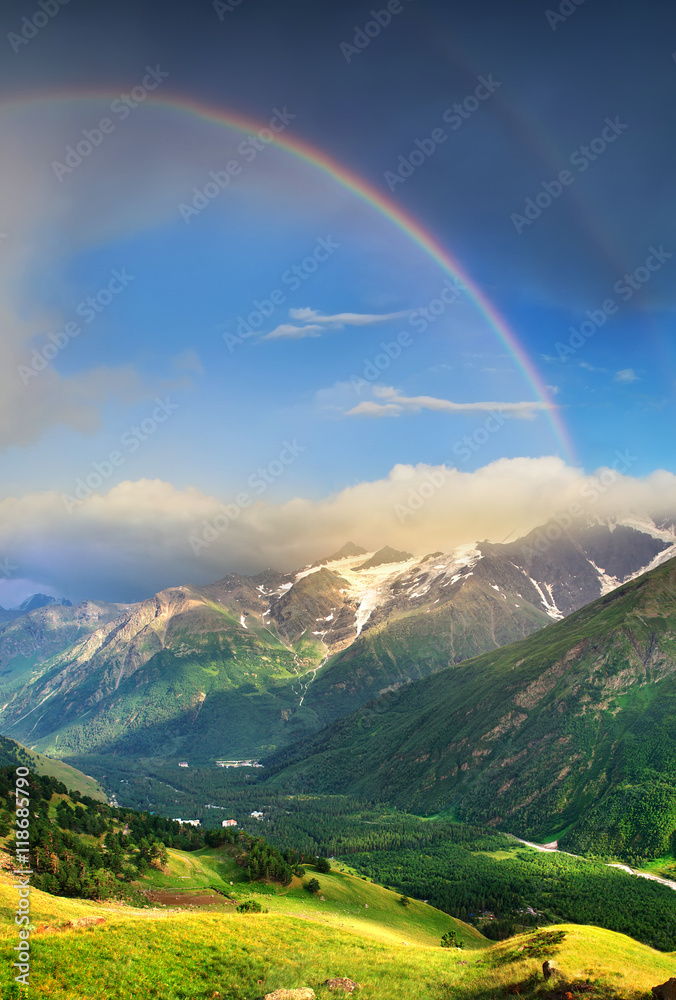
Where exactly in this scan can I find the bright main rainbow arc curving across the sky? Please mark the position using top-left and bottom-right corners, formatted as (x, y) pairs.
(5, 89), (575, 463)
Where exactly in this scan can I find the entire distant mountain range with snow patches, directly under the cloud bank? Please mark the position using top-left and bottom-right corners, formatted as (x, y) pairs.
(0, 519), (676, 762)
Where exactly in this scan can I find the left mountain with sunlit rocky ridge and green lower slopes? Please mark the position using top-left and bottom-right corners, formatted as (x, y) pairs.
(0, 587), (328, 760)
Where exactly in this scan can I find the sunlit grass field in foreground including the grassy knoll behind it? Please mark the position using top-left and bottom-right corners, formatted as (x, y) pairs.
(0, 851), (676, 1000)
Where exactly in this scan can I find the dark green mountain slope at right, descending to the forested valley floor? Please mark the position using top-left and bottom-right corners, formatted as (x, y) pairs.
(266, 560), (676, 858)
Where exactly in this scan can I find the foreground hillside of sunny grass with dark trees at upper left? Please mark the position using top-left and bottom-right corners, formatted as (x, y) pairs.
(0, 769), (676, 1000)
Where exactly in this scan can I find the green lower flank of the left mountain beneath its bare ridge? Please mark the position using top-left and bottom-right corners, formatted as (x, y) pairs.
(0, 602), (323, 761)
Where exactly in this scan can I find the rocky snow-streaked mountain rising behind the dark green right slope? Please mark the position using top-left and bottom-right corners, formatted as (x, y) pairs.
(305, 519), (676, 723)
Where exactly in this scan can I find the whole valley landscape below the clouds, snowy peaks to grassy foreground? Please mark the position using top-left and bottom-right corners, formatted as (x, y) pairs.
(0, 519), (676, 1000)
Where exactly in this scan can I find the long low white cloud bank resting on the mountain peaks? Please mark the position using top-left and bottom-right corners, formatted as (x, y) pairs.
(0, 455), (676, 606)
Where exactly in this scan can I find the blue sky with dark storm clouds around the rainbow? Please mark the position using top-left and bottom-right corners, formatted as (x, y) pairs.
(0, 0), (676, 603)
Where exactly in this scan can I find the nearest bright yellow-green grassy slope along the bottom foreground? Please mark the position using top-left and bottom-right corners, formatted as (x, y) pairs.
(0, 874), (676, 1000)
